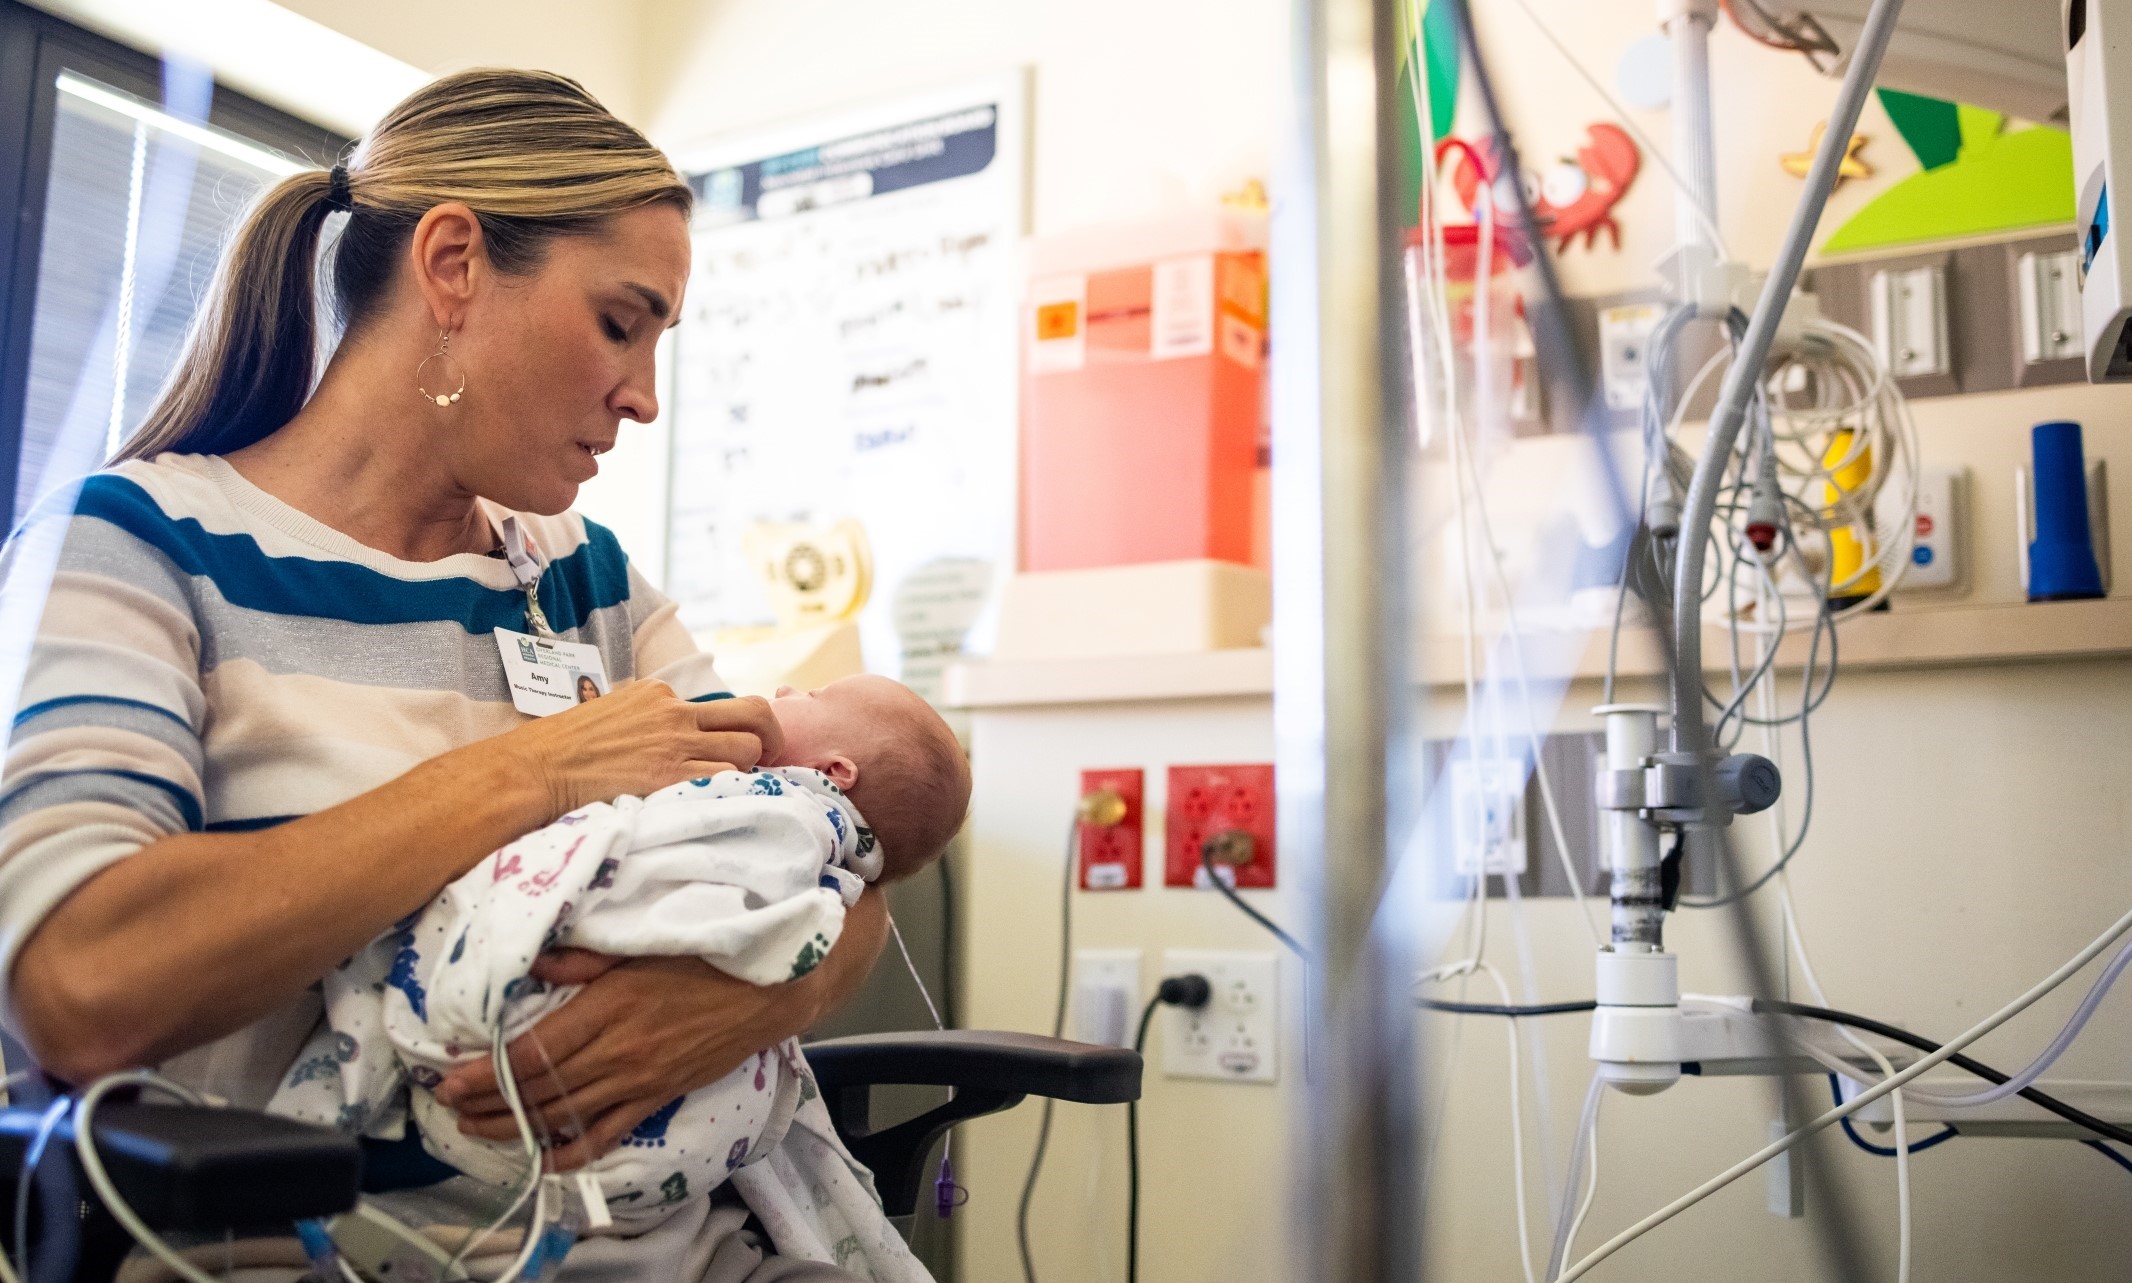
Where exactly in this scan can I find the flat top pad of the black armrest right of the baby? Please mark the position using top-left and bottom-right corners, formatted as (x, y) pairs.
(806, 1029), (1141, 1104)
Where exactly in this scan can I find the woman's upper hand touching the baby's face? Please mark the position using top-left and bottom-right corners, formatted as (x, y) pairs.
(488, 682), (785, 818)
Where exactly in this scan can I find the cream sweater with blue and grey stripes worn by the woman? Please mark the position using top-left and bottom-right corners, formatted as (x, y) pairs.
(0, 454), (723, 1104)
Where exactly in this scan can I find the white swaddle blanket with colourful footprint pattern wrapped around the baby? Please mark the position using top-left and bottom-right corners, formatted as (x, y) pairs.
(269, 767), (927, 1283)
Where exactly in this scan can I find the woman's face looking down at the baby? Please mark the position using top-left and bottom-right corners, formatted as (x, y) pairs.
(449, 202), (689, 514)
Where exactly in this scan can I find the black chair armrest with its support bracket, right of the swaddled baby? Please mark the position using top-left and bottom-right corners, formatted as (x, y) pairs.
(804, 1029), (1141, 1228)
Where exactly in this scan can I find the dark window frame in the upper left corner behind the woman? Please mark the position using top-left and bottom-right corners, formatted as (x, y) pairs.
(0, 0), (350, 529)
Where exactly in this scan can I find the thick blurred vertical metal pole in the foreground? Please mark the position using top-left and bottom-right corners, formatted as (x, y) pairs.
(1273, 0), (1424, 1283)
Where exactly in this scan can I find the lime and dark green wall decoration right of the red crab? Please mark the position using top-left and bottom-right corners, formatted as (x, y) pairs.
(1821, 90), (2072, 254)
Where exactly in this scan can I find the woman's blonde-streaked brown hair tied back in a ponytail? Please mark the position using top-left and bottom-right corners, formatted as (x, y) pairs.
(113, 68), (693, 462)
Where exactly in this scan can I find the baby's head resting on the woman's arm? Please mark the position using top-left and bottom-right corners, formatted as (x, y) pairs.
(765, 673), (970, 882)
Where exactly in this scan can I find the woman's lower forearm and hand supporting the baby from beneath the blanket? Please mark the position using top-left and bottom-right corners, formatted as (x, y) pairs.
(437, 889), (889, 1170)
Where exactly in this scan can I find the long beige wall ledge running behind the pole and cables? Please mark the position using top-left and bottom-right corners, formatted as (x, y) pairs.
(947, 597), (2132, 710)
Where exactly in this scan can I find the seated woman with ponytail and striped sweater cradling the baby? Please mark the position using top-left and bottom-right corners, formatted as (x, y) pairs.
(0, 70), (887, 1279)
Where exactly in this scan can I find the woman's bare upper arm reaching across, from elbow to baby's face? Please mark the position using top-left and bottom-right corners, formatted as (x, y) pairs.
(9, 682), (778, 1083)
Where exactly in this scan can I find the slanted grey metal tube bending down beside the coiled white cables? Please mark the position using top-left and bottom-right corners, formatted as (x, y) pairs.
(1671, 0), (1902, 752)
